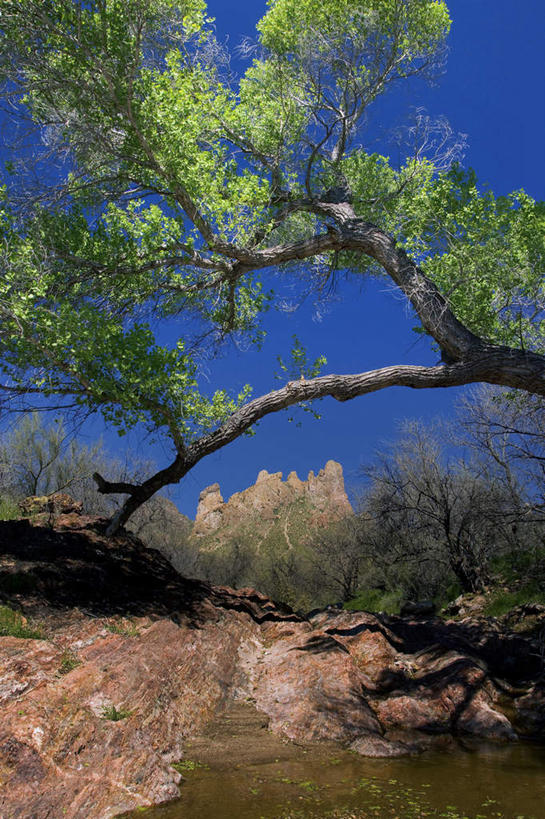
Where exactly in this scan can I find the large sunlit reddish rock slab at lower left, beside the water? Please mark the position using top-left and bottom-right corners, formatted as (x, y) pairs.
(0, 613), (260, 819)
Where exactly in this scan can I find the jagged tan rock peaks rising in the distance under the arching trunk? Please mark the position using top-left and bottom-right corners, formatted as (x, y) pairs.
(193, 461), (352, 538)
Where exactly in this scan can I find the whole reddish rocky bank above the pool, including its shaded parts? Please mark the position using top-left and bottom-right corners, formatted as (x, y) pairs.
(0, 507), (545, 819)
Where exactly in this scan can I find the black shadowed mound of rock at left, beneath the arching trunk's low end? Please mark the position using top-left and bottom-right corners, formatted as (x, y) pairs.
(0, 514), (299, 626)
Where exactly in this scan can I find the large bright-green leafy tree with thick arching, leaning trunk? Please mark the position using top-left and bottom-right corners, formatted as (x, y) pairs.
(0, 0), (545, 533)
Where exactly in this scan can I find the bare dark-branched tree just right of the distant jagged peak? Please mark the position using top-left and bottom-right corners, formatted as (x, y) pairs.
(364, 423), (519, 592)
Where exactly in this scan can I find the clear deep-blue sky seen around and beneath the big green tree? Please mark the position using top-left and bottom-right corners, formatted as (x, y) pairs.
(4, 0), (545, 517)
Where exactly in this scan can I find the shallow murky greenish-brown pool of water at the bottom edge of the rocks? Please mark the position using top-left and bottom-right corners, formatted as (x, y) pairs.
(132, 744), (545, 819)
